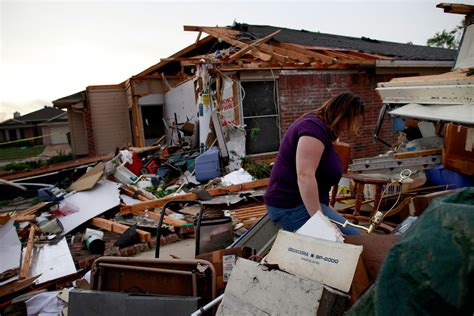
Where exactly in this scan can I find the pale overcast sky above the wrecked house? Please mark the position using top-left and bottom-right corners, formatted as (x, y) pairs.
(0, 0), (466, 121)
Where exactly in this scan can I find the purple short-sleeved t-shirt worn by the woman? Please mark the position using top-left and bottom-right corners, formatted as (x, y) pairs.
(263, 115), (342, 208)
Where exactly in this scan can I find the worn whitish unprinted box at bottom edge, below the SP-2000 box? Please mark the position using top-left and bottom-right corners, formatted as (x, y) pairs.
(216, 258), (349, 315)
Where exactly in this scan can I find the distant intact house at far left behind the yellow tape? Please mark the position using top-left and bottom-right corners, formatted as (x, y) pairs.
(0, 106), (69, 145)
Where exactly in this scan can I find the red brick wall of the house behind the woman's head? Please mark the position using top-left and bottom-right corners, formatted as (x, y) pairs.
(278, 71), (406, 159)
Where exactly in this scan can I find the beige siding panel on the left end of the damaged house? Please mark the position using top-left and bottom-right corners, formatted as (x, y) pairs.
(88, 87), (132, 155)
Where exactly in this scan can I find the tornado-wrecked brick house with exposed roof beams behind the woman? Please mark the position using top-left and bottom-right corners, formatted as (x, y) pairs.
(53, 24), (456, 158)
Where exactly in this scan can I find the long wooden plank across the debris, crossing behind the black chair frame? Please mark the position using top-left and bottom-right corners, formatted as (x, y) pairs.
(121, 178), (268, 213)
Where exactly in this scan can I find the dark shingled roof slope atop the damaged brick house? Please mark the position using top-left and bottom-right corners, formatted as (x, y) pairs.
(233, 24), (457, 61)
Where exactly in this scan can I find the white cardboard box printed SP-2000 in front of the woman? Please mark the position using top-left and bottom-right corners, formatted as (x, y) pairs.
(265, 230), (362, 293)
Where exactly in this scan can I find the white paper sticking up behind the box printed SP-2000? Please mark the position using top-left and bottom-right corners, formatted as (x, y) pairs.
(296, 212), (344, 243)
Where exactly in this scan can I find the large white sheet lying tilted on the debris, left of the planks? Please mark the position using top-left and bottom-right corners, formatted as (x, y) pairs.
(59, 179), (120, 235)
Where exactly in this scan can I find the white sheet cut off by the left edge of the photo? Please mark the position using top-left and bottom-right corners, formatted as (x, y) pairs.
(0, 220), (21, 273)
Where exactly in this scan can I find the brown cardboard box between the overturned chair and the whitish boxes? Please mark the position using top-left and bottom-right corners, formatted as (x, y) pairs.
(196, 247), (254, 291)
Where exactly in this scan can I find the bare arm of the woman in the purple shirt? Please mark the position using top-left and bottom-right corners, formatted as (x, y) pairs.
(296, 136), (324, 216)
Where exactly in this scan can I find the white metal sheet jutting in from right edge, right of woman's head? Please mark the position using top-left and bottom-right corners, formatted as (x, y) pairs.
(389, 103), (474, 124)
